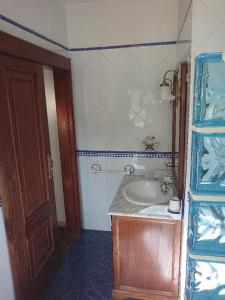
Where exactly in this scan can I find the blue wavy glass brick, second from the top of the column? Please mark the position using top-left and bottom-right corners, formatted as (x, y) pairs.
(191, 132), (225, 195)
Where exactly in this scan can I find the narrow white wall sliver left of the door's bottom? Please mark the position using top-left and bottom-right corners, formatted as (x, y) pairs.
(0, 207), (15, 300)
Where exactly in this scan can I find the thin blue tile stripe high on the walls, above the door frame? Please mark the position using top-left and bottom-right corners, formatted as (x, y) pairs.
(0, 15), (179, 52)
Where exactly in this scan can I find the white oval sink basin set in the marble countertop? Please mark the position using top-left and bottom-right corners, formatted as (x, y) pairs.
(122, 180), (173, 205)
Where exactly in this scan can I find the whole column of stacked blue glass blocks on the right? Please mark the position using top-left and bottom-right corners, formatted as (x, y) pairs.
(186, 53), (225, 300)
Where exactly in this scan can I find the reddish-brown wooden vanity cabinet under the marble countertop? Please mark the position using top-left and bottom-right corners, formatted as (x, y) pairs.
(112, 216), (181, 300)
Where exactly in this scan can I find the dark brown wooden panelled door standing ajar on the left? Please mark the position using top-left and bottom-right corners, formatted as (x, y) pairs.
(0, 55), (58, 300)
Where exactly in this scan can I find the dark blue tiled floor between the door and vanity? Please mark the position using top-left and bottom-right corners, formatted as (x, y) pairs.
(42, 230), (112, 300)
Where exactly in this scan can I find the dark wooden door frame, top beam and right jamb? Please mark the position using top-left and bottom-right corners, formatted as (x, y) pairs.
(0, 31), (80, 235)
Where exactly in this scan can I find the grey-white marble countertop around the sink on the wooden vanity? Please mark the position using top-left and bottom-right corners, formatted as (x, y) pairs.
(108, 175), (181, 220)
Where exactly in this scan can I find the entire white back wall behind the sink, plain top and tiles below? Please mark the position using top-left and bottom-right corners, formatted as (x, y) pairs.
(66, 0), (177, 230)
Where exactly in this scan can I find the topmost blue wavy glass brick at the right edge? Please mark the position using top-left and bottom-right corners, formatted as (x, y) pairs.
(193, 53), (225, 127)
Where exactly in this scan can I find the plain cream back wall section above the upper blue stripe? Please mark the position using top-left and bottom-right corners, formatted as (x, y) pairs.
(66, 0), (178, 48)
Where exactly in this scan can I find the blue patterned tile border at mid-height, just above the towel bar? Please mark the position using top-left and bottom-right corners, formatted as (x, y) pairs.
(76, 150), (178, 158)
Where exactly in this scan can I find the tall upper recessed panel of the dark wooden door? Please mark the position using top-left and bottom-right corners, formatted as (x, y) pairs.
(6, 71), (47, 218)
